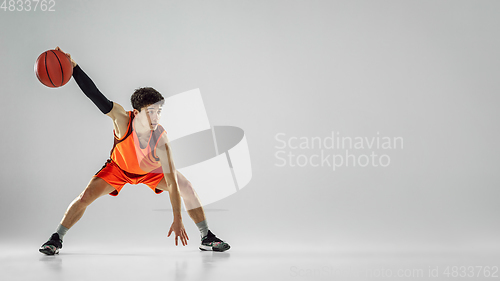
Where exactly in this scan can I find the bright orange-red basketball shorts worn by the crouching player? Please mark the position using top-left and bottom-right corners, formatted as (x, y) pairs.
(95, 160), (163, 196)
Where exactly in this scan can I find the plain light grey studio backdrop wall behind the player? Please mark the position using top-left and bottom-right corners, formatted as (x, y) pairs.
(0, 0), (500, 253)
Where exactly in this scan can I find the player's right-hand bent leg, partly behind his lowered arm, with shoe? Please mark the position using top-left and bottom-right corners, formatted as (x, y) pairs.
(156, 171), (230, 252)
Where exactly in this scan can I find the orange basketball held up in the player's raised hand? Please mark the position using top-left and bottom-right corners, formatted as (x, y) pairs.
(35, 50), (73, 88)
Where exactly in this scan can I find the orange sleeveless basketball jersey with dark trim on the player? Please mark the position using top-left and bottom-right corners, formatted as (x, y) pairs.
(111, 111), (167, 175)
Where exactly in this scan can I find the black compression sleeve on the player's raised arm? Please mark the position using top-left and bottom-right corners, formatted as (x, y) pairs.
(73, 65), (113, 114)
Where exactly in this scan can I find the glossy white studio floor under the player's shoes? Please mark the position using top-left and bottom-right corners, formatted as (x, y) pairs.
(0, 240), (500, 281)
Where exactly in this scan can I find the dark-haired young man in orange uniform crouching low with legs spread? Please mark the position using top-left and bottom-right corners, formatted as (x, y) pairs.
(39, 47), (230, 255)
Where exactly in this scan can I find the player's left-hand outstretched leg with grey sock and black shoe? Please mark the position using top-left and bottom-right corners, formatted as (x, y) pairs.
(39, 177), (115, 255)
